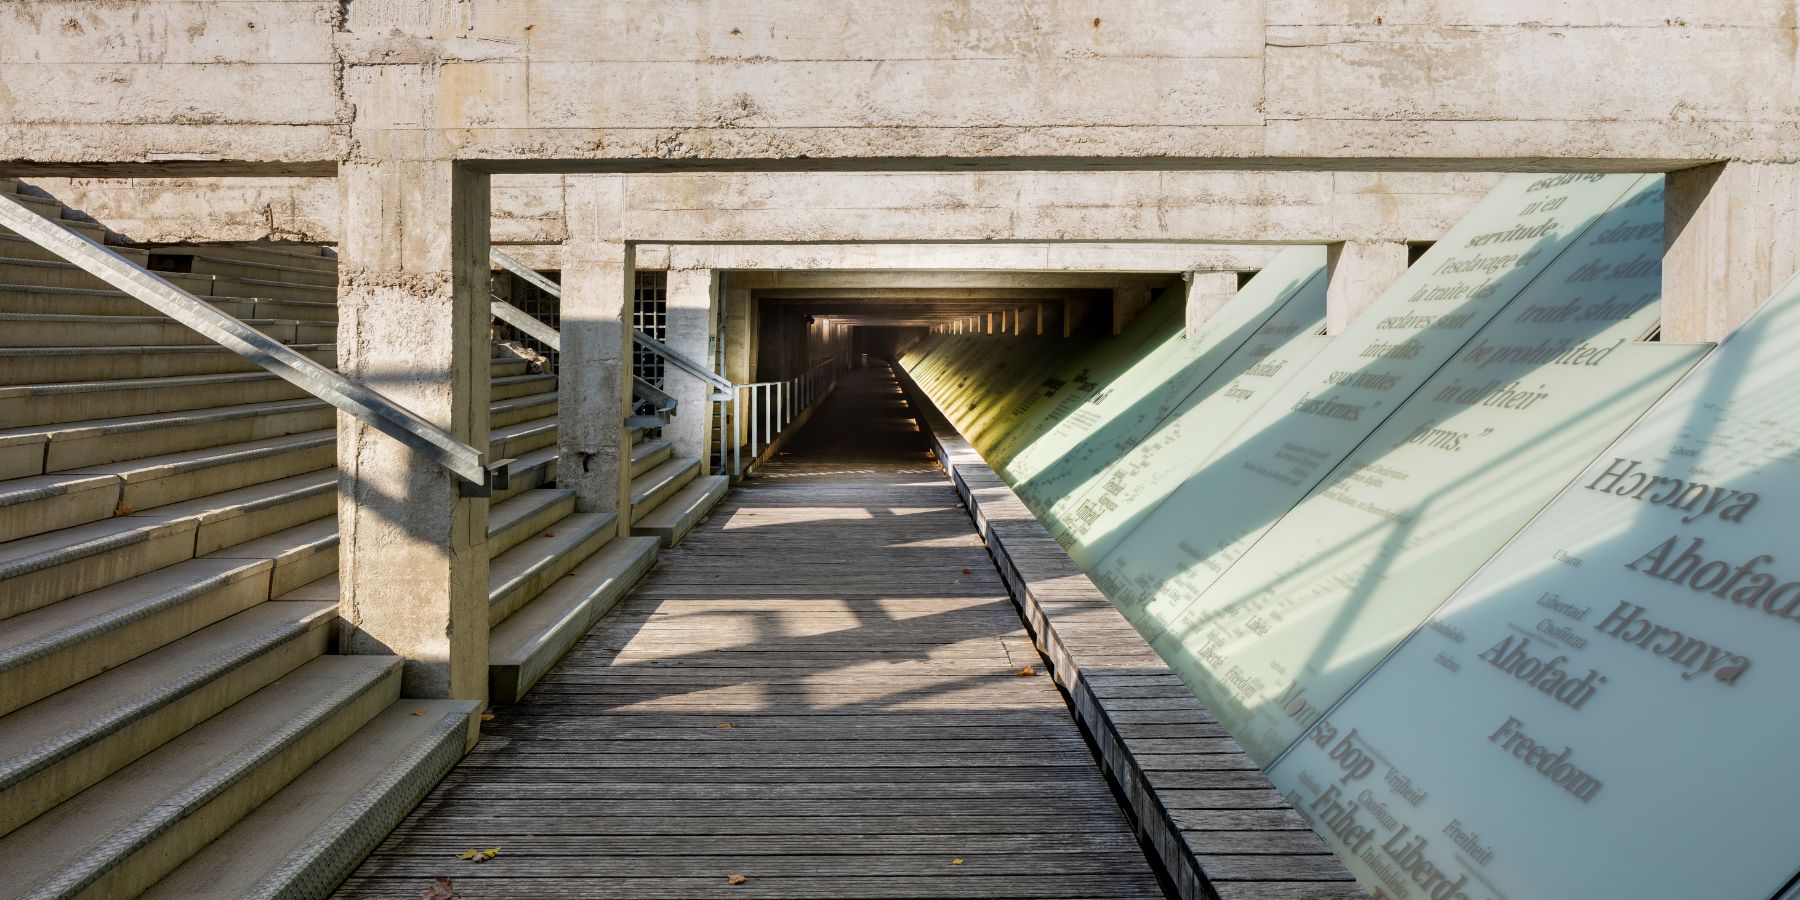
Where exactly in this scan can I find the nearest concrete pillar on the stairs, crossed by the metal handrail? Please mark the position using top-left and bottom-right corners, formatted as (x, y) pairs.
(337, 160), (491, 700)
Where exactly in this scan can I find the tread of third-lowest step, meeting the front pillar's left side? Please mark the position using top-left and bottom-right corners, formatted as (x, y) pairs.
(0, 603), (337, 792)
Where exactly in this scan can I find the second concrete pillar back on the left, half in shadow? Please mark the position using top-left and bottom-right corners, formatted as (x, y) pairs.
(556, 178), (637, 535)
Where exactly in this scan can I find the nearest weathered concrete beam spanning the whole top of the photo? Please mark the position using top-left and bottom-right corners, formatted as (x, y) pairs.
(0, 0), (1800, 175)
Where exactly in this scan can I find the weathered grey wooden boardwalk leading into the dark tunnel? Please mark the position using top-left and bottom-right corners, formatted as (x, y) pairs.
(340, 369), (1163, 900)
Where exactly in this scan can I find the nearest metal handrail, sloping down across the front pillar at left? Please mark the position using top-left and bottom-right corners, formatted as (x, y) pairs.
(0, 194), (511, 495)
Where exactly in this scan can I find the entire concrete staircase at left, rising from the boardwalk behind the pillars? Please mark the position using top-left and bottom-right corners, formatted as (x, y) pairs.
(0, 178), (724, 898)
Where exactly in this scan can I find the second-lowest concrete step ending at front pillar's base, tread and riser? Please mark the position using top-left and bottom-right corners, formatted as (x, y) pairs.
(0, 657), (400, 896)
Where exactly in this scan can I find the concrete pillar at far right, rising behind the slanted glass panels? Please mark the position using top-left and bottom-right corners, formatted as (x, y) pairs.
(1661, 162), (1800, 340)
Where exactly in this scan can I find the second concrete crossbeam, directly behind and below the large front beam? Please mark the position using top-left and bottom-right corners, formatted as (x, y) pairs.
(21, 171), (1498, 246)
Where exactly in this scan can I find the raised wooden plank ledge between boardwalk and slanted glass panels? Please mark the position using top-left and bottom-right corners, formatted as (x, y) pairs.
(895, 365), (1368, 900)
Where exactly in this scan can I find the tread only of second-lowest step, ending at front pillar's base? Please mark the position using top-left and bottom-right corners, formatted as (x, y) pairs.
(0, 657), (400, 893)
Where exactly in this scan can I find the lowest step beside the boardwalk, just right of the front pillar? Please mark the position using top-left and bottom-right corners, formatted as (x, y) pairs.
(488, 536), (661, 704)
